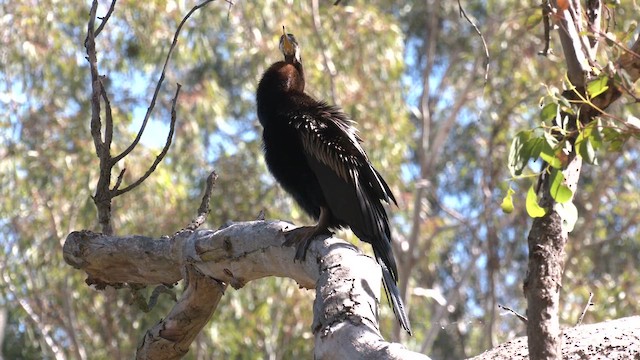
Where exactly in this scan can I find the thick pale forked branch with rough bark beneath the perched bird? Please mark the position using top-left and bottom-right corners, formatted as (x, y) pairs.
(63, 221), (428, 359)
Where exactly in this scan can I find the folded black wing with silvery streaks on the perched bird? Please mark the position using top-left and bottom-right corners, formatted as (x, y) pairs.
(292, 103), (397, 272)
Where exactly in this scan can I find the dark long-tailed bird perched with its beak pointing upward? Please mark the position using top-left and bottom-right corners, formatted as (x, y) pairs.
(256, 27), (411, 334)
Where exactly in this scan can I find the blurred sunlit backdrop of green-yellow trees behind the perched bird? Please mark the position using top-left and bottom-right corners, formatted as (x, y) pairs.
(0, 0), (640, 359)
